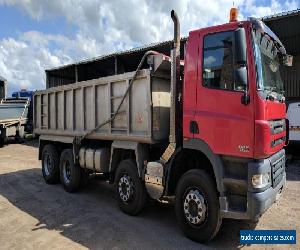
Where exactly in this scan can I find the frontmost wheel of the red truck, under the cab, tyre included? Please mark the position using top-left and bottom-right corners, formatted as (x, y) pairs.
(175, 169), (222, 242)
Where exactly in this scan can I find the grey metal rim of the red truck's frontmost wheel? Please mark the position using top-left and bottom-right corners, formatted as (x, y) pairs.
(183, 189), (207, 226)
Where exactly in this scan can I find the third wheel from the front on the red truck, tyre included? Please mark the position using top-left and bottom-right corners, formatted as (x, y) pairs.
(59, 149), (82, 193)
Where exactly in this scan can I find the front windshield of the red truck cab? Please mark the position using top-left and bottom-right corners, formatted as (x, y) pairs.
(253, 30), (283, 99)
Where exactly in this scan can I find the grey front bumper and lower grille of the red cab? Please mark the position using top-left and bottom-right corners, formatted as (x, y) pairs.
(220, 149), (286, 221)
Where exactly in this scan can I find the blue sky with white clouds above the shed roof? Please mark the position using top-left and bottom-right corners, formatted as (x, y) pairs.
(0, 0), (300, 94)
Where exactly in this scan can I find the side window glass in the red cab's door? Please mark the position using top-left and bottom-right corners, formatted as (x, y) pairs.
(202, 31), (242, 90)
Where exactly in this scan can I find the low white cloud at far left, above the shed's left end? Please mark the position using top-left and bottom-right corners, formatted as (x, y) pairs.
(0, 38), (72, 91)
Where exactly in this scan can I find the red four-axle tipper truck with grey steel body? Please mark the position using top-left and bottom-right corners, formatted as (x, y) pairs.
(34, 10), (292, 242)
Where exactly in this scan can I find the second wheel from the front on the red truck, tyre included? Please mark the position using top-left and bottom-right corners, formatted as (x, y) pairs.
(114, 160), (146, 215)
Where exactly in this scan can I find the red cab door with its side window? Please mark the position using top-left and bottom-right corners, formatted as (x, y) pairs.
(193, 25), (254, 157)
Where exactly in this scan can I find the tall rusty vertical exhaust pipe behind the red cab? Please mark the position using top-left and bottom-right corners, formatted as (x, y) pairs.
(160, 10), (180, 163)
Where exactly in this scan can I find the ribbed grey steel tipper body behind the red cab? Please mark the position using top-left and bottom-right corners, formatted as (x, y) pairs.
(34, 55), (170, 144)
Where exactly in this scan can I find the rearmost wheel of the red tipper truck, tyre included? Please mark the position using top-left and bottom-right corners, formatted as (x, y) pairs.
(42, 144), (59, 184)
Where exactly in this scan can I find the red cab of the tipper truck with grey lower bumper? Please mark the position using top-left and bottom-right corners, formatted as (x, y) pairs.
(178, 19), (286, 238)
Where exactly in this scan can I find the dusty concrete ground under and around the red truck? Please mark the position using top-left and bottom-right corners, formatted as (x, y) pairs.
(0, 142), (300, 249)
